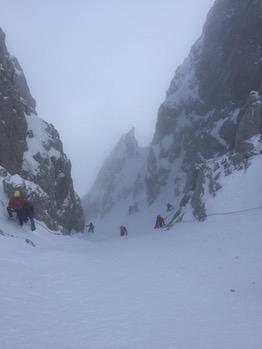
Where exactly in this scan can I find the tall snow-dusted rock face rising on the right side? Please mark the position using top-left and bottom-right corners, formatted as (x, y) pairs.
(83, 0), (262, 220)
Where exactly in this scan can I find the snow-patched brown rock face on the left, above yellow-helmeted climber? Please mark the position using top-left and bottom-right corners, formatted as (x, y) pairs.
(0, 29), (84, 232)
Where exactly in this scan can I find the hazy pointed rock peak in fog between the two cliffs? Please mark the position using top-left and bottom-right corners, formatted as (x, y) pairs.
(82, 129), (147, 220)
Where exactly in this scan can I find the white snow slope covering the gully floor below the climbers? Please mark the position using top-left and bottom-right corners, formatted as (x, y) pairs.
(0, 157), (262, 349)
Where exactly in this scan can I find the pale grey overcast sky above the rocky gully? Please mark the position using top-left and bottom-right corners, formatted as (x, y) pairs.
(0, 0), (214, 196)
